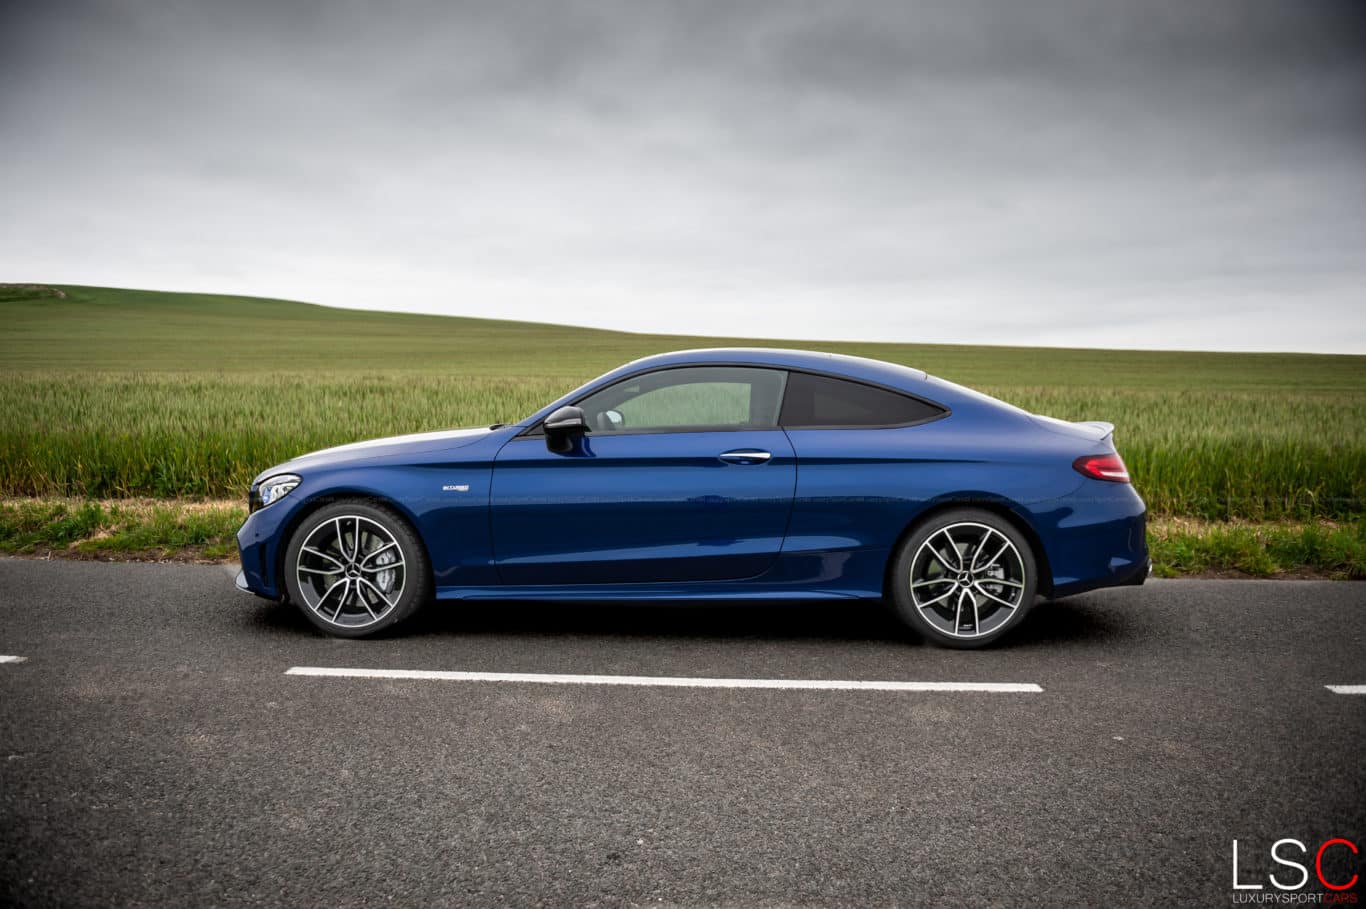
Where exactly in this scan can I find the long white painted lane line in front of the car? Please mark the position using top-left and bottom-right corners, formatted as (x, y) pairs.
(285, 666), (1044, 694)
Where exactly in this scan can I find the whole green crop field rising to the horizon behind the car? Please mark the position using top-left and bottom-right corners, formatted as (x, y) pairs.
(0, 286), (1366, 519)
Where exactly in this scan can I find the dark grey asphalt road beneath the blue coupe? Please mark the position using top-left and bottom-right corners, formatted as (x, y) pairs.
(0, 560), (1366, 906)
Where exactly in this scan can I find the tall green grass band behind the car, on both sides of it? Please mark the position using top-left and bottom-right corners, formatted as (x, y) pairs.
(0, 372), (1366, 518)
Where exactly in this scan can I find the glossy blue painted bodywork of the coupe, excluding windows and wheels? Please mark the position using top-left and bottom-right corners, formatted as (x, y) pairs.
(238, 349), (1147, 600)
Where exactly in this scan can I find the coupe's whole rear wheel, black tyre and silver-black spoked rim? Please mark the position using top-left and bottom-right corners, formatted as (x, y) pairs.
(888, 507), (1038, 649)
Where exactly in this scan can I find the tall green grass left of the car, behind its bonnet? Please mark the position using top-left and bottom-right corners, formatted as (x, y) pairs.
(0, 373), (575, 498)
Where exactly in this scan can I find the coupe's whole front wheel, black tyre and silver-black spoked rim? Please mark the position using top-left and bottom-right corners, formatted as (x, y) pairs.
(283, 499), (432, 637)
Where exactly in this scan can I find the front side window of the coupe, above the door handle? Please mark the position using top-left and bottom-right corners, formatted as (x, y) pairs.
(579, 366), (787, 432)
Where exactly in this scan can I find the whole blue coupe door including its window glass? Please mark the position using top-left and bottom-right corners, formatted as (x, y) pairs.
(490, 366), (796, 585)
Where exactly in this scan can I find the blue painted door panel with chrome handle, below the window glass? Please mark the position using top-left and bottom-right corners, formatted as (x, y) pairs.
(490, 429), (796, 585)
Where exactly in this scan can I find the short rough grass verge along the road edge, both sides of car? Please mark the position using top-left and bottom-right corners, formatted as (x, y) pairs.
(0, 499), (1366, 580)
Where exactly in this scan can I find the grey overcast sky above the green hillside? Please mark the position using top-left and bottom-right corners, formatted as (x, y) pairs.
(0, 0), (1366, 353)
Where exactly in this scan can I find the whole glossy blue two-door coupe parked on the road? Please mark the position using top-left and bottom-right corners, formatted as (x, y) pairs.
(238, 349), (1152, 647)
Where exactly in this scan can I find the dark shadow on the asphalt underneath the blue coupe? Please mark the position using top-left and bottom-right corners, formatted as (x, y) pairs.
(257, 596), (1132, 649)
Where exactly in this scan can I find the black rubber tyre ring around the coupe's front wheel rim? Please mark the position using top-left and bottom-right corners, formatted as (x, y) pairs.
(283, 499), (432, 637)
